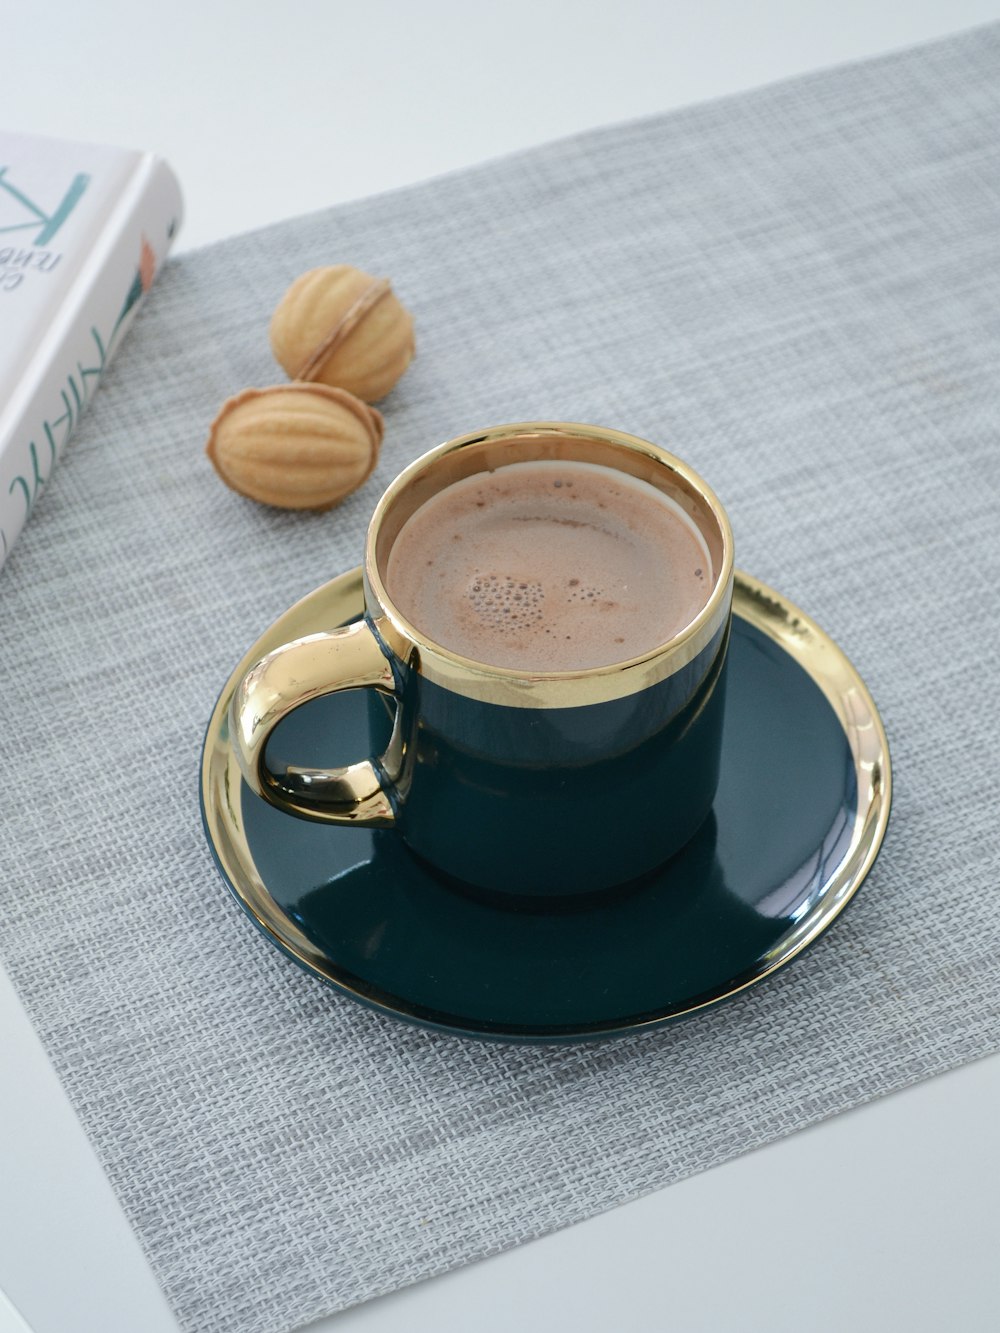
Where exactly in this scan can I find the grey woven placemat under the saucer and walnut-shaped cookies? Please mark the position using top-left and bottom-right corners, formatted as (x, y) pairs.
(0, 28), (1000, 1333)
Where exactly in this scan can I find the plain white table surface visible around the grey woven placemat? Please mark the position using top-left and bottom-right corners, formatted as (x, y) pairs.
(0, 0), (1000, 1333)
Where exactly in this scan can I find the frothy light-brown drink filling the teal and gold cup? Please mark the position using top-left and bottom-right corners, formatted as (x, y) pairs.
(384, 461), (712, 672)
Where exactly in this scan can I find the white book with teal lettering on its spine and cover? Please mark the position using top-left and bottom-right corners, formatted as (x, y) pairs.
(0, 131), (181, 565)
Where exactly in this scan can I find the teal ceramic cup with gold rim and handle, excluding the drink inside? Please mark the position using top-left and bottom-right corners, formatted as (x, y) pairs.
(229, 423), (733, 897)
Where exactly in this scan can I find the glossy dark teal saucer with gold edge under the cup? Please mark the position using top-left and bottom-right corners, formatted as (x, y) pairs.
(201, 571), (891, 1042)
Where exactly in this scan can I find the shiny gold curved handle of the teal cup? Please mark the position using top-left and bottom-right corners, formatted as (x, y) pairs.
(229, 620), (396, 828)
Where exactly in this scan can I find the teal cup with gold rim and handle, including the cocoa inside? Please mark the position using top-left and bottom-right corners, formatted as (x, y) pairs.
(229, 423), (733, 901)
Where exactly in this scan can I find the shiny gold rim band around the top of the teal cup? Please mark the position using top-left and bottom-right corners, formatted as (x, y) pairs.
(364, 421), (735, 708)
